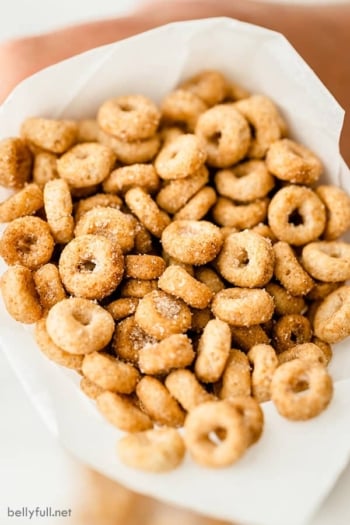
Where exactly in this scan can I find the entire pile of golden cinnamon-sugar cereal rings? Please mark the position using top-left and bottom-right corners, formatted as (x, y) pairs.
(0, 71), (350, 472)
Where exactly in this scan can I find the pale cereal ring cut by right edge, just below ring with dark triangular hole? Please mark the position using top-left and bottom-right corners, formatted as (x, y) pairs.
(301, 241), (350, 283)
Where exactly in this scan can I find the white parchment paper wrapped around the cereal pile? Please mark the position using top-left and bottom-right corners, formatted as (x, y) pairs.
(0, 18), (350, 525)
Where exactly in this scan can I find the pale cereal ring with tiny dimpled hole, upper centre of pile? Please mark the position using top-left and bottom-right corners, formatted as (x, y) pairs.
(154, 133), (207, 180)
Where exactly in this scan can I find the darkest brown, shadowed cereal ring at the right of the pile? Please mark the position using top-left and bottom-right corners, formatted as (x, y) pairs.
(273, 314), (312, 353)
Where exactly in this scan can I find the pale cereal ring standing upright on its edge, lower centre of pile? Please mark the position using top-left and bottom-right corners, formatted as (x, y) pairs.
(194, 319), (231, 383)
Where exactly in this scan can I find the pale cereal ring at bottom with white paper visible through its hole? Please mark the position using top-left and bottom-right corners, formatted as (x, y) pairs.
(185, 401), (250, 468)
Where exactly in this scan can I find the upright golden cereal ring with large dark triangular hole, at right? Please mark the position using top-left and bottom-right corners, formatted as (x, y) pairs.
(268, 186), (326, 246)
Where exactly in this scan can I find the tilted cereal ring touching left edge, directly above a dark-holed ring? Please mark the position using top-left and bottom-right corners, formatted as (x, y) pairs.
(0, 184), (43, 222)
